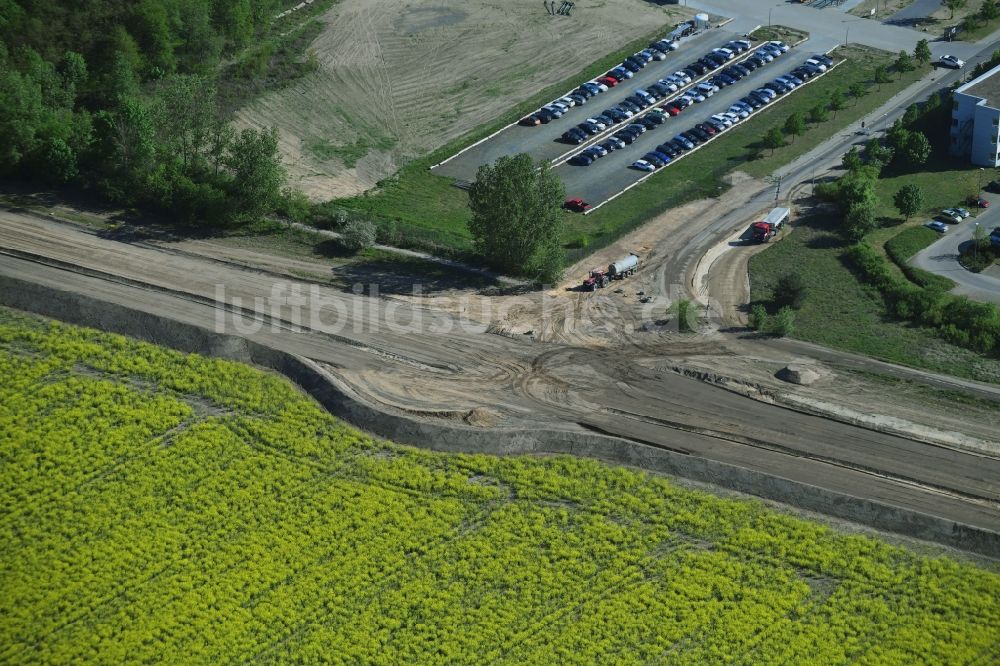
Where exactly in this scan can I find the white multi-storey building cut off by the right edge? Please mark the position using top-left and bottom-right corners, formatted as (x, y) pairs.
(951, 65), (1000, 167)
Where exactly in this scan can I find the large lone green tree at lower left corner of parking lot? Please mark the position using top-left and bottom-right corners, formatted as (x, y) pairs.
(469, 153), (565, 282)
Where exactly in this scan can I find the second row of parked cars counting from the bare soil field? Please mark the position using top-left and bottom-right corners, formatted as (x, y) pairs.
(562, 40), (760, 145)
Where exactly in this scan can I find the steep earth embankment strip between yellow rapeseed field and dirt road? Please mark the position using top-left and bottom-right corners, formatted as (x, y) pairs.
(0, 276), (1000, 558)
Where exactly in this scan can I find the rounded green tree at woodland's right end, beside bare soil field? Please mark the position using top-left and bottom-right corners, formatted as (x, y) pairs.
(223, 128), (285, 223)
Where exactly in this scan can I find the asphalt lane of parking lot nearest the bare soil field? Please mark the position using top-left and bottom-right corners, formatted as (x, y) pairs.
(432, 29), (737, 179)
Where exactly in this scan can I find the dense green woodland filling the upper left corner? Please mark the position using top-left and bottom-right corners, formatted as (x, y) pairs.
(0, 0), (292, 224)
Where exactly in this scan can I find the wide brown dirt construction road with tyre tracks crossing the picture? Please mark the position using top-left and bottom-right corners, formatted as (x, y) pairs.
(0, 212), (1000, 544)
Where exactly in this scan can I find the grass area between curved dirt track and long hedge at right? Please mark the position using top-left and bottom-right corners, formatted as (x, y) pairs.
(750, 215), (1000, 382)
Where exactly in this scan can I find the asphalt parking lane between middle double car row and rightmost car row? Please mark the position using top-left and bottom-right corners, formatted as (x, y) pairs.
(556, 42), (828, 206)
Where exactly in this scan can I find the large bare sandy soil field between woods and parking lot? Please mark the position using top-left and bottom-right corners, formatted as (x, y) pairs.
(238, 0), (692, 201)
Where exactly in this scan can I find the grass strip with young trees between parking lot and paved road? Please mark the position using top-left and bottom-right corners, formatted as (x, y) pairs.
(566, 45), (925, 259)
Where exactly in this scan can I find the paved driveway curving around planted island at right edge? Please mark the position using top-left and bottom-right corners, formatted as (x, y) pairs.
(911, 208), (1000, 305)
